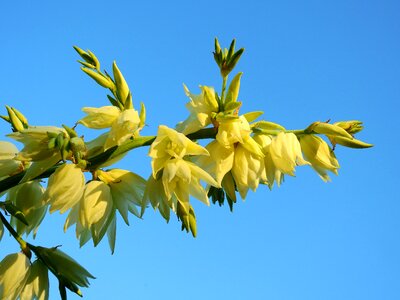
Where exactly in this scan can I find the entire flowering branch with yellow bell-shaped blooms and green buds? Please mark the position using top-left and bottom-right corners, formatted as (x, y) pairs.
(0, 42), (371, 299)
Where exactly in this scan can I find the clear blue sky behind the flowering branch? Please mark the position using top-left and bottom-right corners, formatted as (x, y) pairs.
(0, 0), (400, 300)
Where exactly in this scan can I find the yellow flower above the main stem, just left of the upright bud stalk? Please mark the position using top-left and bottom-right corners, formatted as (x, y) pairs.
(177, 85), (218, 134)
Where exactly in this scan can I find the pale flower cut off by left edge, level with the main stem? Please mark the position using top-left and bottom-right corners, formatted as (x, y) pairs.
(0, 141), (24, 178)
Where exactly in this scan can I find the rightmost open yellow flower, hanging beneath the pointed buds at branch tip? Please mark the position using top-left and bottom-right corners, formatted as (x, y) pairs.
(300, 134), (339, 182)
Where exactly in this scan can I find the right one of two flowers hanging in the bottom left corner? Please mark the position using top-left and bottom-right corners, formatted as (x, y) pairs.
(20, 259), (49, 300)
